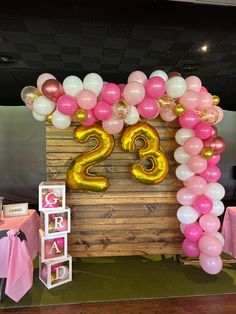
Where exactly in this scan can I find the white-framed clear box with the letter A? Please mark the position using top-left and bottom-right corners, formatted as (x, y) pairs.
(39, 229), (67, 262)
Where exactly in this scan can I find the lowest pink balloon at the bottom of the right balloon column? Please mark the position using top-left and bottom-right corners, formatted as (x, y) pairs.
(199, 253), (222, 275)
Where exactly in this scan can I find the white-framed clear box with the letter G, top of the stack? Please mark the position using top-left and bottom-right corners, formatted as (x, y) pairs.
(39, 180), (66, 211)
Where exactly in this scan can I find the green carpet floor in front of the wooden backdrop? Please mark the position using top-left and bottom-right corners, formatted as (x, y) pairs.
(0, 256), (236, 307)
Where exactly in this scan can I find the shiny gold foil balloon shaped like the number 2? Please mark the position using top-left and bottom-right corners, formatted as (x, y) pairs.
(67, 125), (115, 192)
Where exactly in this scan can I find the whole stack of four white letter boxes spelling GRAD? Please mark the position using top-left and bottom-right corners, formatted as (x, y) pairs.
(39, 181), (72, 289)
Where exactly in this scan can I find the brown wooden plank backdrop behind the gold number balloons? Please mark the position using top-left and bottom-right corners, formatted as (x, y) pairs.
(46, 119), (183, 257)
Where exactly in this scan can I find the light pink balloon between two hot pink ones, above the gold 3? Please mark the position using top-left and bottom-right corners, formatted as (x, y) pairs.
(123, 82), (145, 105)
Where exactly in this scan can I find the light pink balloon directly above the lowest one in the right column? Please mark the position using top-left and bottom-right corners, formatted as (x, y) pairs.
(198, 235), (222, 256)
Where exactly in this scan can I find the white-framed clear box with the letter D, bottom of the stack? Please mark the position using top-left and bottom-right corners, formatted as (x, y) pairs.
(39, 255), (72, 289)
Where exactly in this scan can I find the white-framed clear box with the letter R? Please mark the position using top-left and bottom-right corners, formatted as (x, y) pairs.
(40, 207), (71, 236)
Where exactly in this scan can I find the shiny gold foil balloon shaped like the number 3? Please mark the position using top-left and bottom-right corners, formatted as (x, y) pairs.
(121, 122), (169, 184)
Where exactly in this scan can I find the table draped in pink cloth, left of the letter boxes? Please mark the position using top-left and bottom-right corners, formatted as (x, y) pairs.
(0, 209), (39, 302)
